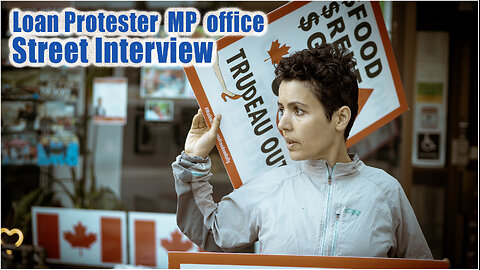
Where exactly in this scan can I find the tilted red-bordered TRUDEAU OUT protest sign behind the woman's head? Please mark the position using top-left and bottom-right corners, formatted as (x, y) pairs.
(185, 2), (408, 188)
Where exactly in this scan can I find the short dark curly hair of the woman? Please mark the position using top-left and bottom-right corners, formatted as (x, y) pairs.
(275, 43), (358, 140)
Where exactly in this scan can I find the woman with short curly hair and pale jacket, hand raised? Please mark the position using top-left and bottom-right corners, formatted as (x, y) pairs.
(172, 44), (432, 259)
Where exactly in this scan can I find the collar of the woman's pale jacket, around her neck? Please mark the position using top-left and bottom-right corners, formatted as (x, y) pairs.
(302, 154), (363, 176)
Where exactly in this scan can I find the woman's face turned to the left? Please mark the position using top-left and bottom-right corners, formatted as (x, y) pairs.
(278, 80), (337, 160)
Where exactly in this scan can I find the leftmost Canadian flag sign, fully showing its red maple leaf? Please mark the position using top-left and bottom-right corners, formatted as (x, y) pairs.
(32, 207), (127, 266)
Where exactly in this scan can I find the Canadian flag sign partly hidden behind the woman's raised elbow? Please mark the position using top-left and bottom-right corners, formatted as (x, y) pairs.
(128, 212), (202, 268)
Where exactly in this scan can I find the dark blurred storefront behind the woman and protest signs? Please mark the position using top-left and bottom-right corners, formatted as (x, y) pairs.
(1, 1), (478, 268)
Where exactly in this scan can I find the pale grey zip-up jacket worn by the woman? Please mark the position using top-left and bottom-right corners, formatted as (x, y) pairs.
(172, 153), (433, 259)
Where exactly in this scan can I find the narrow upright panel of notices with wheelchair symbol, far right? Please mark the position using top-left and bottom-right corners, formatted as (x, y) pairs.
(412, 31), (449, 168)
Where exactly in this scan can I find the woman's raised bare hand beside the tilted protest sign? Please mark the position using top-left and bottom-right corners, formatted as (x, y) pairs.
(185, 109), (222, 158)
